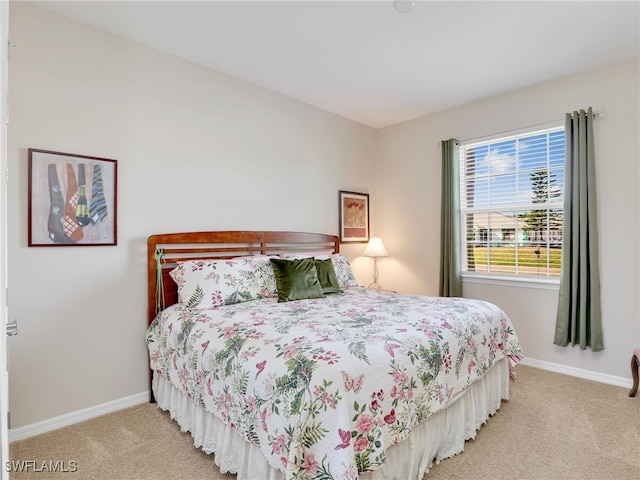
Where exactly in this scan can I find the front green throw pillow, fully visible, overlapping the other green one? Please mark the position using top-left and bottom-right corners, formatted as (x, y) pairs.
(271, 257), (324, 302)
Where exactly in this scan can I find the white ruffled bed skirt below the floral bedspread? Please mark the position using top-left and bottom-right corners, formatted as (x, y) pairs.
(152, 358), (509, 480)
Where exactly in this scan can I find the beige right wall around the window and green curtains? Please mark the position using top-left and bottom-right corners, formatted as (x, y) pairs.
(375, 60), (640, 378)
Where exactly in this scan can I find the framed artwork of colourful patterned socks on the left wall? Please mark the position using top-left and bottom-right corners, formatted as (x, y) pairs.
(28, 148), (118, 247)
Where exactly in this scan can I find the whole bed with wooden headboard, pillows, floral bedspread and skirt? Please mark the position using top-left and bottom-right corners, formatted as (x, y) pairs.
(146, 231), (522, 480)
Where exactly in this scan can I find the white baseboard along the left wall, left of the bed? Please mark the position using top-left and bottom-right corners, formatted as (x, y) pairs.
(9, 392), (149, 443)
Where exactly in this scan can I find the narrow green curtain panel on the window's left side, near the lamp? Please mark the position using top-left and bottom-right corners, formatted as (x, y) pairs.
(439, 138), (462, 297)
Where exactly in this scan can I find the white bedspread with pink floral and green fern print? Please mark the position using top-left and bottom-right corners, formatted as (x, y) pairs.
(147, 288), (522, 480)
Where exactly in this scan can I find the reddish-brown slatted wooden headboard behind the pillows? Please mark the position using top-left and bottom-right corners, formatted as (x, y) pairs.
(147, 231), (340, 324)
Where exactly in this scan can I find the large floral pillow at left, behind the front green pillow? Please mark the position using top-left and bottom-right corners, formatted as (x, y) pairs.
(170, 257), (277, 309)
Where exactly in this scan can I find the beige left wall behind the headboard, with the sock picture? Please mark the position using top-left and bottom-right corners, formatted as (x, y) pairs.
(8, 2), (375, 428)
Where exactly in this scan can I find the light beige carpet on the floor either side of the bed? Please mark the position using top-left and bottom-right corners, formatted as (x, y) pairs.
(10, 366), (640, 480)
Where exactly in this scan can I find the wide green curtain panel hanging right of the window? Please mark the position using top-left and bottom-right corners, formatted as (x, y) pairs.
(553, 108), (604, 352)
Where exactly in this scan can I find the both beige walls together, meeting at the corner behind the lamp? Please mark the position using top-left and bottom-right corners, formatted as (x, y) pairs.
(8, 2), (640, 428)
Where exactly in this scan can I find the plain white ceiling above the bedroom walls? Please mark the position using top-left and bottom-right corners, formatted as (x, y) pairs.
(28, 0), (640, 128)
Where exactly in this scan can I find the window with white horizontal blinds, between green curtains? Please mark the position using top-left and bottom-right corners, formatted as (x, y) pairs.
(460, 126), (565, 278)
